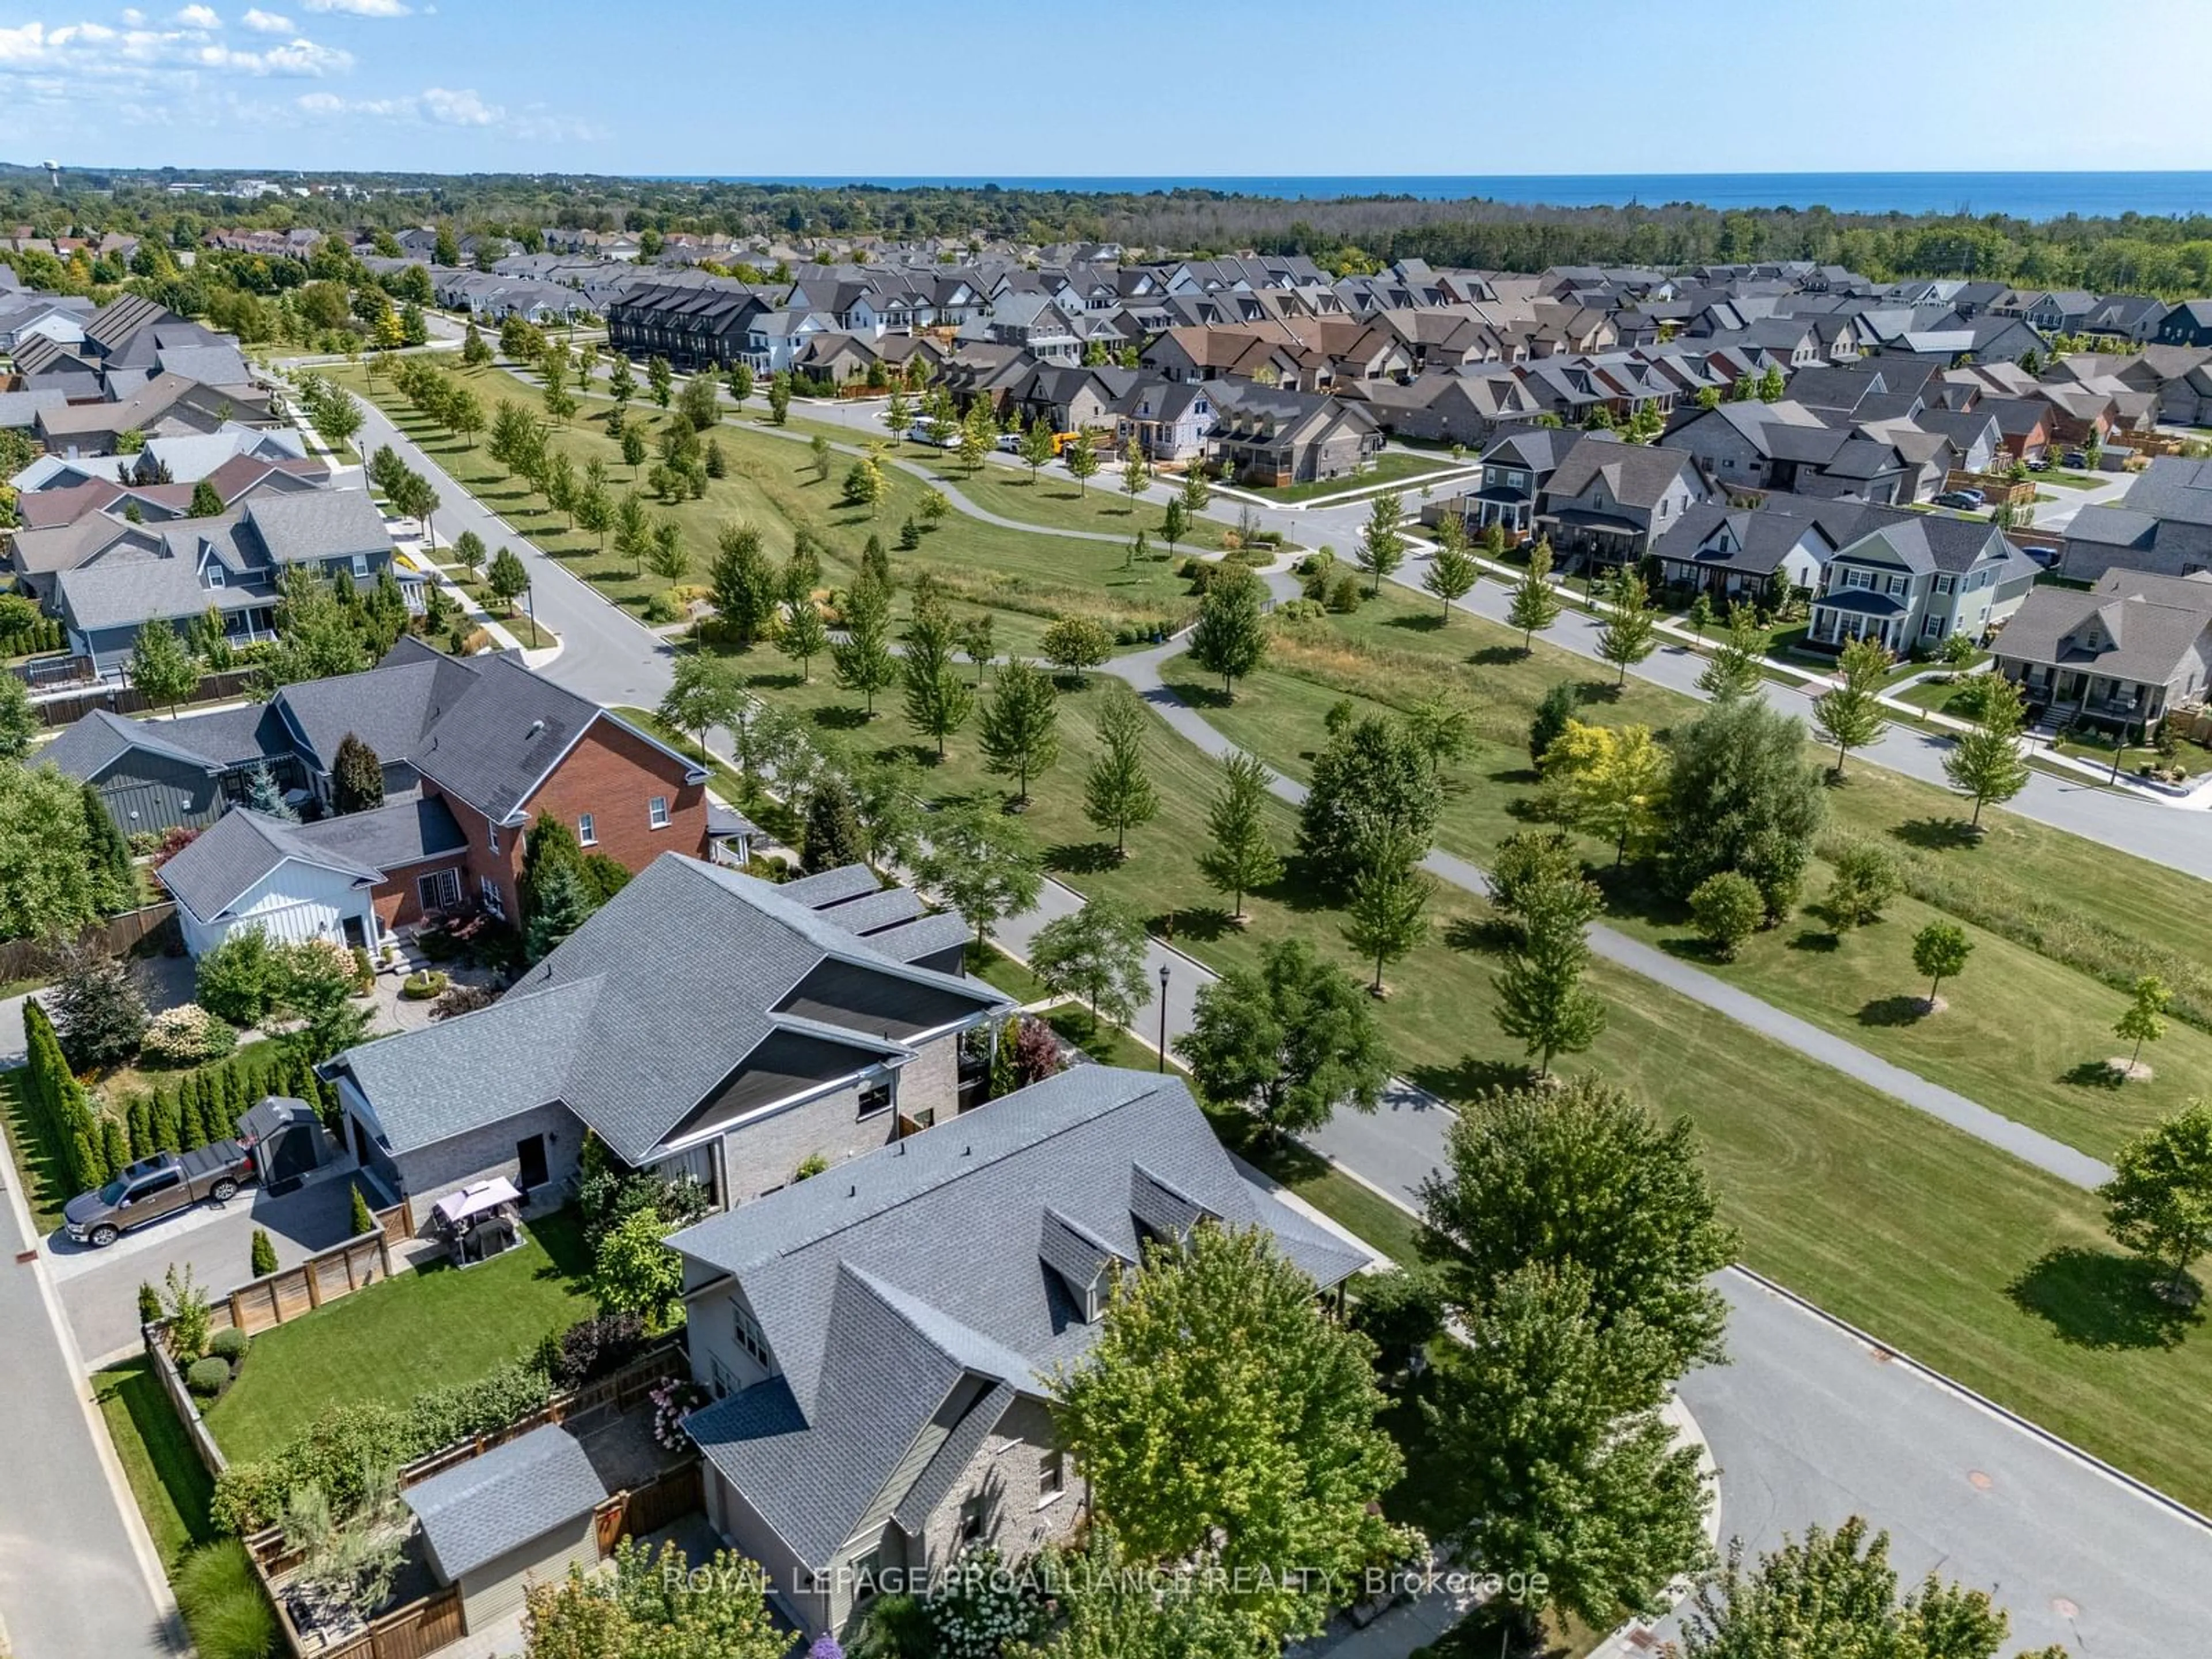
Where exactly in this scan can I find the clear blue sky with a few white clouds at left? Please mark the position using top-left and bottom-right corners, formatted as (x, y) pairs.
(0, 0), (2212, 177)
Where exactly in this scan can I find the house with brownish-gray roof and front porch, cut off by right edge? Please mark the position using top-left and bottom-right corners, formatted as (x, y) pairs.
(1991, 571), (2212, 737)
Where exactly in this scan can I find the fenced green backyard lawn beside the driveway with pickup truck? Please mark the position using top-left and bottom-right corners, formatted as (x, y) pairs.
(208, 1212), (593, 1460)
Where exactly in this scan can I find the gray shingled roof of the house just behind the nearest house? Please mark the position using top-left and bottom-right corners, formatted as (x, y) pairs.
(334, 854), (1006, 1164)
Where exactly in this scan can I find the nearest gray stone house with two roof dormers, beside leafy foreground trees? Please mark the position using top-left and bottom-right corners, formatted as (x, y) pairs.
(671, 1066), (1365, 1635)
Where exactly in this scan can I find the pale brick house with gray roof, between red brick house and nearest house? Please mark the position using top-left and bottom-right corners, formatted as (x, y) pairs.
(327, 851), (1011, 1217)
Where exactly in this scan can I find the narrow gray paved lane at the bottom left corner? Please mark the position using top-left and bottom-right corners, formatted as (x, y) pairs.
(0, 1161), (184, 1659)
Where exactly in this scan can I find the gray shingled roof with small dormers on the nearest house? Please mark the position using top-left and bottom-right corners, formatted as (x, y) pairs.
(671, 1066), (1365, 1566)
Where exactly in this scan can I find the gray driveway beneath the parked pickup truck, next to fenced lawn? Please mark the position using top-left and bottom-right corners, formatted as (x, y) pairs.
(54, 1175), (367, 1367)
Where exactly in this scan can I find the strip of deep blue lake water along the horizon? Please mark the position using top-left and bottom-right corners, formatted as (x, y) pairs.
(694, 173), (2212, 219)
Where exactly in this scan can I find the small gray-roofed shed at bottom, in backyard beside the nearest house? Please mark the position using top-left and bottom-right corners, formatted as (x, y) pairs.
(405, 1425), (606, 1630)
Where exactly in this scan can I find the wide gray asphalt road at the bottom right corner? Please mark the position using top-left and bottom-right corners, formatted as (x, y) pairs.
(1659, 1272), (2212, 1659)
